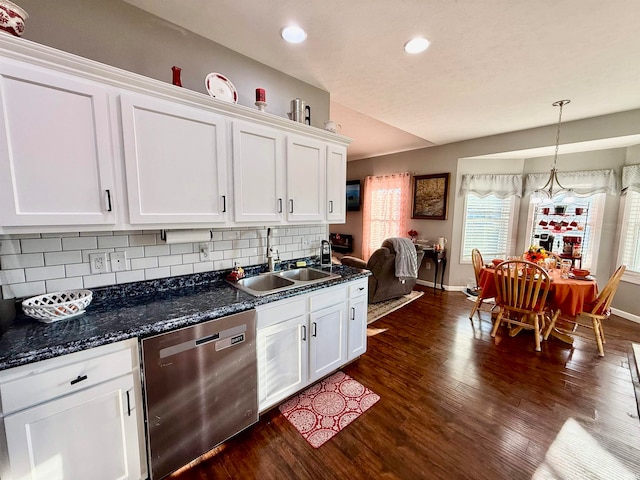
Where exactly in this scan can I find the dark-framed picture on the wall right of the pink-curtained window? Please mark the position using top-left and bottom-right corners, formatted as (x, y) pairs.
(411, 173), (449, 220)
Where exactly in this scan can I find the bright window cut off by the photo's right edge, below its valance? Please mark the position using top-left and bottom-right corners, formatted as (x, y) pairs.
(620, 190), (640, 283)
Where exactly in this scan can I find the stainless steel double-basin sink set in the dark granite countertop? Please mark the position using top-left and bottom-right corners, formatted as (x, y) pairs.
(229, 268), (340, 297)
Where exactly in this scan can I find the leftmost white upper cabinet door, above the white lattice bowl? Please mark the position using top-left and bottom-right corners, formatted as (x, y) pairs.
(0, 62), (115, 226)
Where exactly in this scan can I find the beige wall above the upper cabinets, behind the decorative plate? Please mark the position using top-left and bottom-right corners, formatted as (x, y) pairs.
(19, 0), (329, 128)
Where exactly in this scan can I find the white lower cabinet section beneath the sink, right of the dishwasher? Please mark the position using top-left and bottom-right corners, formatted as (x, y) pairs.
(256, 281), (367, 411)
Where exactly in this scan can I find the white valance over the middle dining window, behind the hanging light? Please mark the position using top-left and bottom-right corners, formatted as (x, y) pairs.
(524, 168), (618, 197)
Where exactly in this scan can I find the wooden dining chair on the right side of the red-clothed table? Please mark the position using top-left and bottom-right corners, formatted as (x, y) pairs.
(544, 265), (627, 357)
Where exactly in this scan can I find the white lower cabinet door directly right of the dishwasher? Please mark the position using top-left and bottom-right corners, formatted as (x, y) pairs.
(257, 315), (309, 411)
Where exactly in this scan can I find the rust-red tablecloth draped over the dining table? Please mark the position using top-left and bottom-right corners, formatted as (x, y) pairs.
(480, 267), (598, 316)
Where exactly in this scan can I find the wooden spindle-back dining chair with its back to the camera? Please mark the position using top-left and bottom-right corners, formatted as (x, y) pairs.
(491, 260), (551, 352)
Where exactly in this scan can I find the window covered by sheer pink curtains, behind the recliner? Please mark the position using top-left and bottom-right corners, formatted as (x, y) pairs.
(362, 173), (411, 259)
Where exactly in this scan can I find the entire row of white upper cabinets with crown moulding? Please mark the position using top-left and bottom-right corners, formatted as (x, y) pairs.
(0, 35), (349, 234)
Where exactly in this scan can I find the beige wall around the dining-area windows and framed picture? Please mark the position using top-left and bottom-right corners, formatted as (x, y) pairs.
(340, 110), (640, 317)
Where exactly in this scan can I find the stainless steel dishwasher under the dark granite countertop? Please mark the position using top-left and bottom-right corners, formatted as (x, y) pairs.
(142, 310), (258, 480)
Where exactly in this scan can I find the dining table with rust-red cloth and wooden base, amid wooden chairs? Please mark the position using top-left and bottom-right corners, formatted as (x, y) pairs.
(479, 265), (598, 345)
